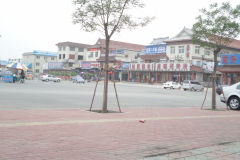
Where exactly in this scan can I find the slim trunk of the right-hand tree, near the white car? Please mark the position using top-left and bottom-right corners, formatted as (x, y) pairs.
(212, 48), (221, 110)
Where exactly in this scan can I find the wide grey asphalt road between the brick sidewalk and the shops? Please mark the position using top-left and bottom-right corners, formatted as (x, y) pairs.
(0, 80), (225, 110)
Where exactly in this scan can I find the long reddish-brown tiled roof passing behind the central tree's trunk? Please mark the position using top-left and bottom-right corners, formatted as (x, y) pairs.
(95, 38), (144, 52)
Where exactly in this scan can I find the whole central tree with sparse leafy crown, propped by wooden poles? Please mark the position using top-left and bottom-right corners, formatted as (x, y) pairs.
(73, 0), (152, 112)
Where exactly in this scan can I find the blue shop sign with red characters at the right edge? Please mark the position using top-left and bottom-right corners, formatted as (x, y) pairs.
(221, 54), (240, 65)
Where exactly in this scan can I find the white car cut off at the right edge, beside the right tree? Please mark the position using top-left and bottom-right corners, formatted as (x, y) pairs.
(220, 82), (240, 110)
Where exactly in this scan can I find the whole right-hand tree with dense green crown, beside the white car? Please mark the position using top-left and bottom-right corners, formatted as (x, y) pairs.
(192, 2), (240, 110)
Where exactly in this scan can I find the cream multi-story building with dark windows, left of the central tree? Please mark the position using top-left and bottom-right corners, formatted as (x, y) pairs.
(56, 42), (92, 69)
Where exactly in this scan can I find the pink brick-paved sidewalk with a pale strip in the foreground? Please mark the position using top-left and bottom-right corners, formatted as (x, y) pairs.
(0, 108), (240, 160)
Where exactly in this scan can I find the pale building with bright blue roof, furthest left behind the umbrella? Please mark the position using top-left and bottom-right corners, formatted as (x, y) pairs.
(23, 50), (57, 77)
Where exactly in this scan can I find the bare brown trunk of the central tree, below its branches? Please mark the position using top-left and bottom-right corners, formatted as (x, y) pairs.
(102, 37), (110, 113)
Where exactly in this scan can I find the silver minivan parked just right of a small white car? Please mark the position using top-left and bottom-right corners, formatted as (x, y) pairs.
(182, 80), (204, 91)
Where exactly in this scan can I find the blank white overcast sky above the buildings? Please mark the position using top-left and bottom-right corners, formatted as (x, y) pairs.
(0, 0), (240, 60)
